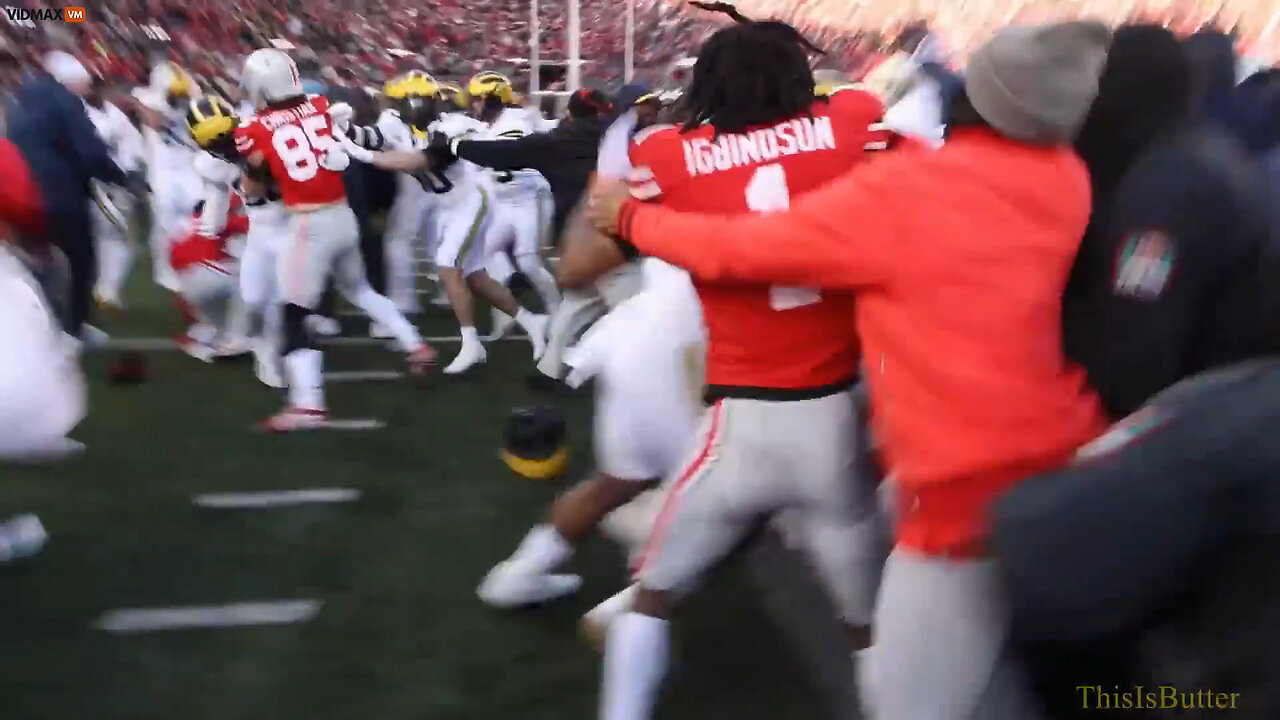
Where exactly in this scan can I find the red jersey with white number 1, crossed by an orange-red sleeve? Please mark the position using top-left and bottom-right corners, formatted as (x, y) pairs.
(631, 88), (888, 393)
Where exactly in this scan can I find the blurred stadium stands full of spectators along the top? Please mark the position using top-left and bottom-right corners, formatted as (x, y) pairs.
(9, 0), (1280, 91)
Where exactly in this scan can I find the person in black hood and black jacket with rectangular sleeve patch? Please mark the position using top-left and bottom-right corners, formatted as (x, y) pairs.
(1064, 26), (1280, 420)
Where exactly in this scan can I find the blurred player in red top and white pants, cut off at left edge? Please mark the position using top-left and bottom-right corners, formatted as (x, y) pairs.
(0, 140), (86, 562)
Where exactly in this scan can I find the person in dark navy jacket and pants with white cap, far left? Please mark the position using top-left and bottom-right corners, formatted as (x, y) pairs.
(9, 53), (127, 340)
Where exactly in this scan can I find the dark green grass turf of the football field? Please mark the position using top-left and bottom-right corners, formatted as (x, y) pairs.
(0, 269), (818, 720)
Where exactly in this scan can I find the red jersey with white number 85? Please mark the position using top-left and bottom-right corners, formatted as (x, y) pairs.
(236, 95), (347, 208)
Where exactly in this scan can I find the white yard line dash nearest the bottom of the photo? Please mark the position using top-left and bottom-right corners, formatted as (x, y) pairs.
(93, 600), (324, 634)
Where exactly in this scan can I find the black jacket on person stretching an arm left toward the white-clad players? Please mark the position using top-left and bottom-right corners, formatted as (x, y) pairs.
(458, 118), (604, 238)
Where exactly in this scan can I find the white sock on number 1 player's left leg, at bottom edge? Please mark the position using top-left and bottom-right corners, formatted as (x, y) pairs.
(599, 612), (671, 720)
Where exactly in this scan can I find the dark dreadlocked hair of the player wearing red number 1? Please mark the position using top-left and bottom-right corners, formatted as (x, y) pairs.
(681, 20), (822, 135)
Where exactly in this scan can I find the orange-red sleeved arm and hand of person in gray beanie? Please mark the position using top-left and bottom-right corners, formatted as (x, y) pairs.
(591, 161), (905, 288)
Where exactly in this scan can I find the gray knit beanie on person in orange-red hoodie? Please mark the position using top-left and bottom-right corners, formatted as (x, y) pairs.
(965, 22), (1111, 145)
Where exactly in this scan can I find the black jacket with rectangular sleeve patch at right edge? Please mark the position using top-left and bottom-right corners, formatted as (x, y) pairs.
(1062, 126), (1280, 418)
